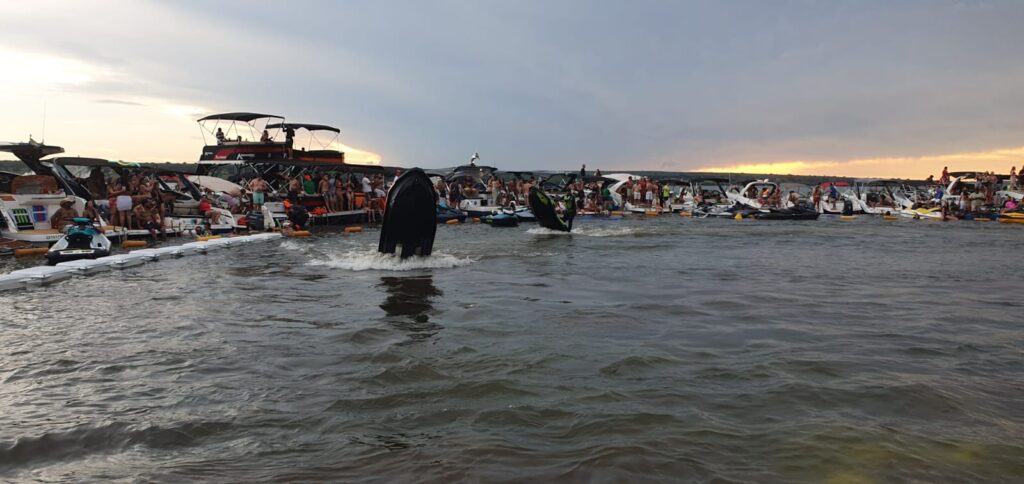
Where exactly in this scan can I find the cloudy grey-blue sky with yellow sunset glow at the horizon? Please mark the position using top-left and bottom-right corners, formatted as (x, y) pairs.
(0, 0), (1024, 178)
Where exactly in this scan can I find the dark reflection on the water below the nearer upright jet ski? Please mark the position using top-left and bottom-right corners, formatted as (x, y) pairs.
(379, 274), (443, 341)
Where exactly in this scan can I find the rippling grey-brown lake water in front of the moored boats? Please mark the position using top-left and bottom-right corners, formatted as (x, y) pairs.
(0, 216), (1024, 482)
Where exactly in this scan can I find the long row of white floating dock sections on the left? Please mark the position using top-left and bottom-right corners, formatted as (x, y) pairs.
(0, 232), (284, 291)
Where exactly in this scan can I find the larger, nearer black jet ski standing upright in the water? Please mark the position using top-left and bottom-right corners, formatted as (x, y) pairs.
(377, 168), (437, 259)
